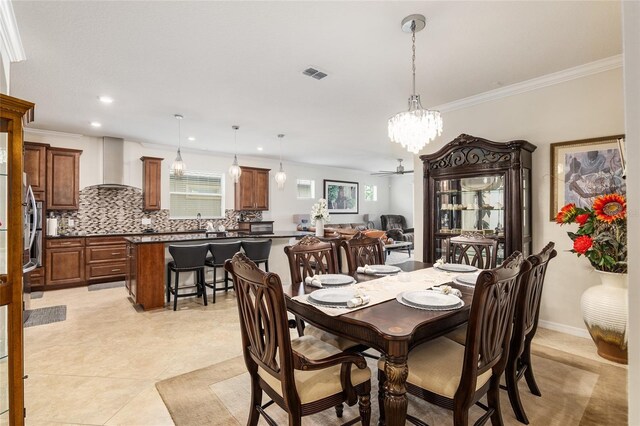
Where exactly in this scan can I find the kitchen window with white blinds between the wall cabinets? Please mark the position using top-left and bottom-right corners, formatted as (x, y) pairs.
(169, 170), (224, 219)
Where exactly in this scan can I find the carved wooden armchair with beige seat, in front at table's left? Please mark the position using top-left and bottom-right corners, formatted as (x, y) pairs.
(224, 253), (371, 426)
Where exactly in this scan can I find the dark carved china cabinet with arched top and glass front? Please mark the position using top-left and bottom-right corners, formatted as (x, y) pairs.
(420, 134), (536, 263)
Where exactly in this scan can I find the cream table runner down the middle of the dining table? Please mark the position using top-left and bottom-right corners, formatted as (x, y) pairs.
(293, 268), (460, 317)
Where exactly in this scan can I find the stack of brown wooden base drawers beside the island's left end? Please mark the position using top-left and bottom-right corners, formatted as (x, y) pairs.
(85, 237), (127, 283)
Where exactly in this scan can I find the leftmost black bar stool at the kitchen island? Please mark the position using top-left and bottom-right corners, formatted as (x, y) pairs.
(167, 244), (209, 311)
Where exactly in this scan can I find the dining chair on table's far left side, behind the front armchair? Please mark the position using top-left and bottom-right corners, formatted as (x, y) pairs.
(284, 235), (366, 351)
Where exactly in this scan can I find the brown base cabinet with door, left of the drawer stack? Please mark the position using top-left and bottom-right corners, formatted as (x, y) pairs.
(45, 238), (85, 288)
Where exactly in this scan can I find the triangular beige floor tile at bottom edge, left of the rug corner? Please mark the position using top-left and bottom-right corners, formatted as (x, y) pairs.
(106, 385), (173, 426)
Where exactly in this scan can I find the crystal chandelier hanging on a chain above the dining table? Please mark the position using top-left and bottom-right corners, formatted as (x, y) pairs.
(388, 15), (442, 154)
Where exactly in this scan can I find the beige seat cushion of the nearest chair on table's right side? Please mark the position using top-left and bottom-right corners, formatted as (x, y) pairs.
(378, 337), (491, 399)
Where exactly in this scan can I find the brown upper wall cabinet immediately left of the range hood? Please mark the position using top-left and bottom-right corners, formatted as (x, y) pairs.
(46, 148), (82, 210)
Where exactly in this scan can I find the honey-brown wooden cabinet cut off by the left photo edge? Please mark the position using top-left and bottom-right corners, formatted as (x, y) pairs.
(0, 93), (34, 425)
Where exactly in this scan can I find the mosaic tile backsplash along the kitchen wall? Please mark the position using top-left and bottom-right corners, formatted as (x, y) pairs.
(47, 186), (262, 234)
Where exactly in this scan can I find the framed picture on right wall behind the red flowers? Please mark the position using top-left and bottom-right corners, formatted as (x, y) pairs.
(550, 135), (627, 220)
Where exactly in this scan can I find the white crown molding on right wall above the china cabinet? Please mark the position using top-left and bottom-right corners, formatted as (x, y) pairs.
(429, 55), (622, 112)
